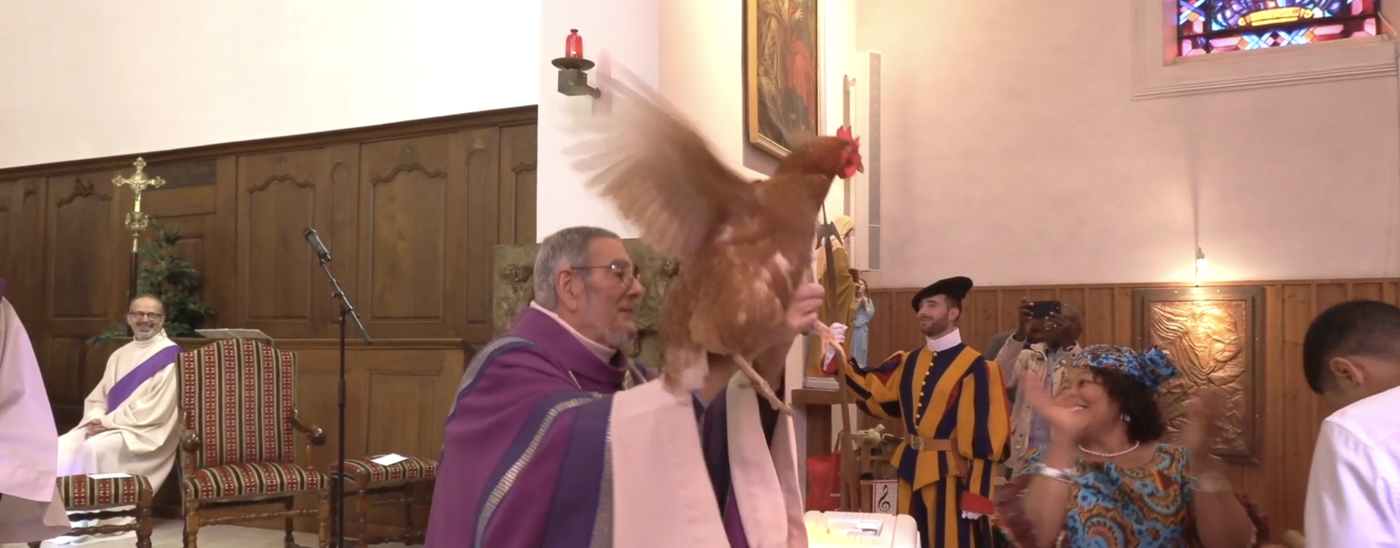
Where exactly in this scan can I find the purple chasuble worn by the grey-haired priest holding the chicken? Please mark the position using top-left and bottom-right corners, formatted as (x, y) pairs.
(426, 308), (777, 548)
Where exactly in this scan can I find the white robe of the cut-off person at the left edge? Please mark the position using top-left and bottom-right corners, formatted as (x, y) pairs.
(0, 299), (69, 544)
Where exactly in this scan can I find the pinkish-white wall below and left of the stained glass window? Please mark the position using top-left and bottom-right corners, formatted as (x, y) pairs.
(857, 0), (1400, 287)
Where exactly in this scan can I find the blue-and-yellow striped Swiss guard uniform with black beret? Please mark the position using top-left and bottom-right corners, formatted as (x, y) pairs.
(844, 276), (1011, 548)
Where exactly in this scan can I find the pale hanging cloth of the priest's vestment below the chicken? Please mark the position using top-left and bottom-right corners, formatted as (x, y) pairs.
(608, 376), (808, 548)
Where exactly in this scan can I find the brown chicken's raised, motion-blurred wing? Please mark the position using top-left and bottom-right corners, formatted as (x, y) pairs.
(566, 70), (756, 261)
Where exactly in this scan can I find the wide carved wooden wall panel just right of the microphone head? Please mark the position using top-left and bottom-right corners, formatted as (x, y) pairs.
(357, 133), (466, 338)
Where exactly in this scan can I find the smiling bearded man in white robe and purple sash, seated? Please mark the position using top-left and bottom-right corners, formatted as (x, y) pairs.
(56, 294), (181, 542)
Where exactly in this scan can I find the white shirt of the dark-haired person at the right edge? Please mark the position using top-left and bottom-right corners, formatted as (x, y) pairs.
(1303, 388), (1400, 548)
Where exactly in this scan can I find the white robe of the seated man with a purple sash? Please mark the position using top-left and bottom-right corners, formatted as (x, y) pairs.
(57, 331), (179, 489)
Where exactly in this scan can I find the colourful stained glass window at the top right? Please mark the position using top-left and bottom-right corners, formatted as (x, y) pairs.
(1176, 0), (1380, 57)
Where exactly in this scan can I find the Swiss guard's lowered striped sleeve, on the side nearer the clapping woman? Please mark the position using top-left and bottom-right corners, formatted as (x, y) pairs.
(956, 359), (1011, 514)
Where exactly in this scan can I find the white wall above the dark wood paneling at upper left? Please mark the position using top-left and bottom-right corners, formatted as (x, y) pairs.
(0, 0), (537, 168)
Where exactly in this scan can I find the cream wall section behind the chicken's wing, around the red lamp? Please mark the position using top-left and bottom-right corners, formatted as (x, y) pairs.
(536, 0), (855, 238)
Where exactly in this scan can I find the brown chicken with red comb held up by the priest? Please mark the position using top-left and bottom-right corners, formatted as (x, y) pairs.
(568, 68), (865, 415)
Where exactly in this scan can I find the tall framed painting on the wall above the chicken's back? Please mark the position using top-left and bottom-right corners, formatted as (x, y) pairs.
(743, 0), (822, 158)
